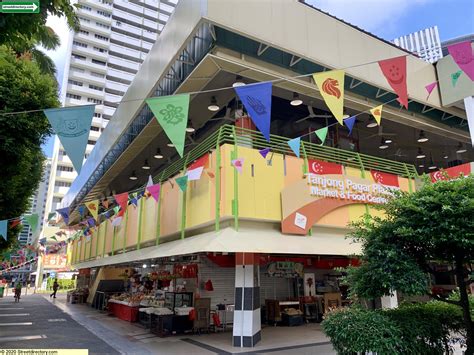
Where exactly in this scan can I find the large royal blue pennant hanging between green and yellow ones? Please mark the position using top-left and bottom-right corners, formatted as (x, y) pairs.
(234, 82), (272, 141)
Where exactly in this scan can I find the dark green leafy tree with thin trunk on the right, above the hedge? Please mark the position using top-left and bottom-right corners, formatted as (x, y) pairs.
(347, 176), (474, 354)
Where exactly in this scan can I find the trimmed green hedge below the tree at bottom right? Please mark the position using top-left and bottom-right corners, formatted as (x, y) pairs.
(322, 301), (463, 355)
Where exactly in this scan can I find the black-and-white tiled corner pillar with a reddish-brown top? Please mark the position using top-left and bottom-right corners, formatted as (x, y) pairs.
(232, 253), (261, 348)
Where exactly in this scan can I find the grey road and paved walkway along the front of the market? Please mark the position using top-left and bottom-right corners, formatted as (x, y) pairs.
(0, 294), (336, 355)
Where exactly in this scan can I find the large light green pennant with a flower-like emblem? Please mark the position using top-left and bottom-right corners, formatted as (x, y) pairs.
(145, 94), (189, 157)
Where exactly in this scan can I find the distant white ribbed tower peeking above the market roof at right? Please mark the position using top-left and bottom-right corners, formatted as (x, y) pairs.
(393, 26), (443, 63)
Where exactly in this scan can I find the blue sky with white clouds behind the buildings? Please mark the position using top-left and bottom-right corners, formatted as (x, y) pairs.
(43, 0), (474, 157)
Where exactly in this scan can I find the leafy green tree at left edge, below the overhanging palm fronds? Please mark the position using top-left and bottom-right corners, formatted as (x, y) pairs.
(0, 46), (59, 251)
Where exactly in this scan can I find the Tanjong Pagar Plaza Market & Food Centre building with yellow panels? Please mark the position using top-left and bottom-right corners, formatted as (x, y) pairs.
(62, 0), (474, 347)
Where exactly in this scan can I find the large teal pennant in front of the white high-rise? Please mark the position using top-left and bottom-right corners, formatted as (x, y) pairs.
(43, 105), (95, 174)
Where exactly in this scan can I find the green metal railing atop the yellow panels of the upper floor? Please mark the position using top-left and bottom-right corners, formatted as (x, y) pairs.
(153, 125), (418, 182)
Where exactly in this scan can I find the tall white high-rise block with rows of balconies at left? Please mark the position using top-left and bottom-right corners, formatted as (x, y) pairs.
(48, 0), (177, 212)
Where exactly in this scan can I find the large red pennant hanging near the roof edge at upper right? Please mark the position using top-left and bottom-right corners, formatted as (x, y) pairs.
(379, 55), (408, 109)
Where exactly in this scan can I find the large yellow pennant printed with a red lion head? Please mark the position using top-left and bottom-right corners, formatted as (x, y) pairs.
(313, 70), (344, 124)
